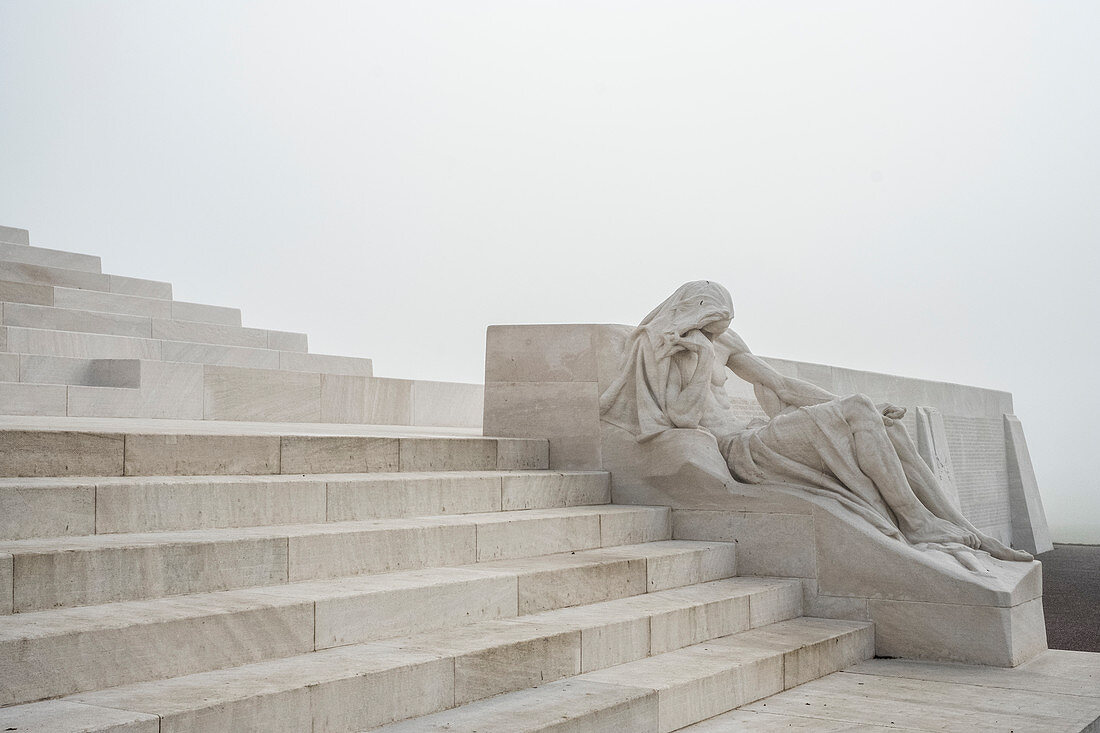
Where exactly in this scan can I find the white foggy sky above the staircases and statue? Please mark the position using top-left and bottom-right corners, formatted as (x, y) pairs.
(0, 0), (1100, 541)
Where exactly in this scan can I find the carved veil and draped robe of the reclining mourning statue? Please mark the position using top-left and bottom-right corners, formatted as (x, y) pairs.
(600, 281), (998, 556)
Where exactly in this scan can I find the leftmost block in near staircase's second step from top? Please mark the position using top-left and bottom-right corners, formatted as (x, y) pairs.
(0, 480), (96, 539)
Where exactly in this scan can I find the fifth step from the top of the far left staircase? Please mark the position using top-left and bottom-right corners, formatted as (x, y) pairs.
(0, 303), (308, 352)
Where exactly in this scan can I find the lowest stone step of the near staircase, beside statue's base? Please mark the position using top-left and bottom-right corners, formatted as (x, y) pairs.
(375, 619), (875, 733)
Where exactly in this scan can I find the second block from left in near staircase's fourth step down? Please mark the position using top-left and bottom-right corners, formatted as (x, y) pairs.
(316, 568), (516, 648)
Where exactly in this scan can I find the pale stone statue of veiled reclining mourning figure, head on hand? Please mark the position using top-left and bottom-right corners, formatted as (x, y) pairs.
(600, 281), (1032, 572)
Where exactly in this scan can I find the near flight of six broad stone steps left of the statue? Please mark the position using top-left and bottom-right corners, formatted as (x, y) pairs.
(0, 423), (873, 732)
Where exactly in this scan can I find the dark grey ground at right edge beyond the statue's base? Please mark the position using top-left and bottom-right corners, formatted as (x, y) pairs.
(1038, 545), (1100, 652)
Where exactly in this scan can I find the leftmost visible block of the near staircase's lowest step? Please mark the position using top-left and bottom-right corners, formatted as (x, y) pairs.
(378, 679), (657, 733)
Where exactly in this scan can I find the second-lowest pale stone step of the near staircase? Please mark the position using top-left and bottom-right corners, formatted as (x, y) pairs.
(0, 579), (801, 732)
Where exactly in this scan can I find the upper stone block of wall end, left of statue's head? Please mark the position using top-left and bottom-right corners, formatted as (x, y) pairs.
(485, 324), (600, 384)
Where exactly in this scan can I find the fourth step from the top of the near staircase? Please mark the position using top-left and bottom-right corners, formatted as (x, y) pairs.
(0, 541), (739, 705)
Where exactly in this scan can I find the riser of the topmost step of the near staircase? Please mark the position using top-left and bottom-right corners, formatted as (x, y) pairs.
(0, 431), (549, 477)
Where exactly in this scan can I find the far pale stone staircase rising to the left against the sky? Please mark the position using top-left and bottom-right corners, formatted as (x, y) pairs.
(0, 228), (482, 428)
